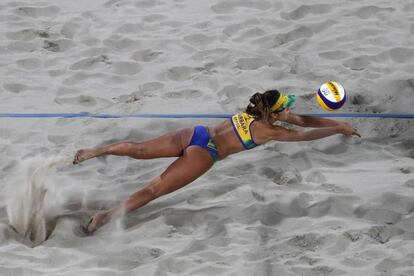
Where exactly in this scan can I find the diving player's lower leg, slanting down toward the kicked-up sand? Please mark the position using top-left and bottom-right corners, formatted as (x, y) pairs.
(85, 146), (213, 233)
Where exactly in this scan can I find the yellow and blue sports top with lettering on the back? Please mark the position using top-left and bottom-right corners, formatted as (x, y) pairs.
(231, 113), (257, 149)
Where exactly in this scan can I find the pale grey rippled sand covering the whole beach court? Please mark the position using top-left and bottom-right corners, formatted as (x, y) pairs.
(0, 0), (414, 276)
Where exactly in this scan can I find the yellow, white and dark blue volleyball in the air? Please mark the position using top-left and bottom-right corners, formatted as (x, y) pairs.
(316, 81), (346, 111)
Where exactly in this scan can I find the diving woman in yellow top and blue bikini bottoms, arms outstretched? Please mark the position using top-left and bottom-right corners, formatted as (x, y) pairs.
(73, 90), (360, 233)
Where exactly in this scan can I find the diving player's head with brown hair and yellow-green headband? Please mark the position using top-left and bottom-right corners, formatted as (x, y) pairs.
(246, 89), (295, 122)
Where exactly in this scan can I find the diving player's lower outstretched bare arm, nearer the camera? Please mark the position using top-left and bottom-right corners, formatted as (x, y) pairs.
(272, 124), (361, 141)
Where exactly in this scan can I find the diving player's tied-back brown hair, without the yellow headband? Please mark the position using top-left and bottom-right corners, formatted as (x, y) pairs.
(245, 89), (280, 121)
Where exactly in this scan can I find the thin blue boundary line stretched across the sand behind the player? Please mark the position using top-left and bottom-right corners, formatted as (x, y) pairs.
(0, 112), (414, 119)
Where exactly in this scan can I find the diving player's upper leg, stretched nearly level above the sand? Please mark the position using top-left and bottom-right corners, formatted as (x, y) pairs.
(73, 128), (193, 164)
